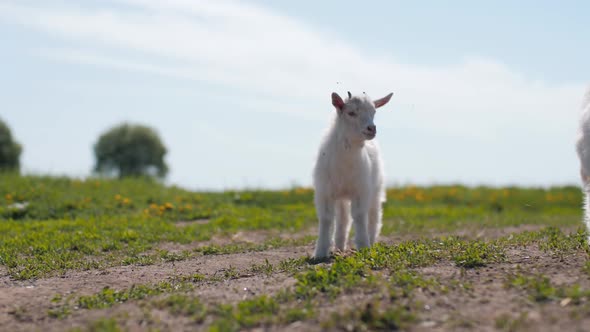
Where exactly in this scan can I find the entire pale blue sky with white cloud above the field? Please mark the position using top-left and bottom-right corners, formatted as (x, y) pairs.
(0, 0), (590, 189)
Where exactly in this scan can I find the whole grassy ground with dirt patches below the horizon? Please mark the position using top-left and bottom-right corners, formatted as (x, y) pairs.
(0, 174), (590, 331)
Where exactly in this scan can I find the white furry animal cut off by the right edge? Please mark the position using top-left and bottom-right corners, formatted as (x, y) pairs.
(576, 89), (590, 236)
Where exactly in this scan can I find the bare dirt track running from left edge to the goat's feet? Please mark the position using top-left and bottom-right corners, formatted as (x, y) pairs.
(0, 247), (311, 331)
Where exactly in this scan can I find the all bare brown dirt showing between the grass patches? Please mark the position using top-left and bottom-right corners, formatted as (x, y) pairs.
(0, 225), (590, 331)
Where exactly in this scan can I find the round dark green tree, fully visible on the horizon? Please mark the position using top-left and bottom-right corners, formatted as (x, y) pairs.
(94, 123), (168, 178)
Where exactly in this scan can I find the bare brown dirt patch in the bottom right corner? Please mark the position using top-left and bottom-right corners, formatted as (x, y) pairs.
(415, 246), (590, 331)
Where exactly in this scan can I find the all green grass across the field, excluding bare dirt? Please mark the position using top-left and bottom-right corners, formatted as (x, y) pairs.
(0, 174), (590, 331)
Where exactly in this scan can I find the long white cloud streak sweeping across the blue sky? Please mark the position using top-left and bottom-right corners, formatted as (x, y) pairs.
(0, 0), (584, 187)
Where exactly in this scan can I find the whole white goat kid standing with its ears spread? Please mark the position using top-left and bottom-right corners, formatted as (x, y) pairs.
(314, 92), (393, 258)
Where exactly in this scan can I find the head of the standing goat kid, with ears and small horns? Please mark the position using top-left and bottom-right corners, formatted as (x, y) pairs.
(332, 92), (393, 140)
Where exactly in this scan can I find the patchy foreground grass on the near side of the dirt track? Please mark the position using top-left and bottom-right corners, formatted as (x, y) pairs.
(48, 228), (590, 331)
